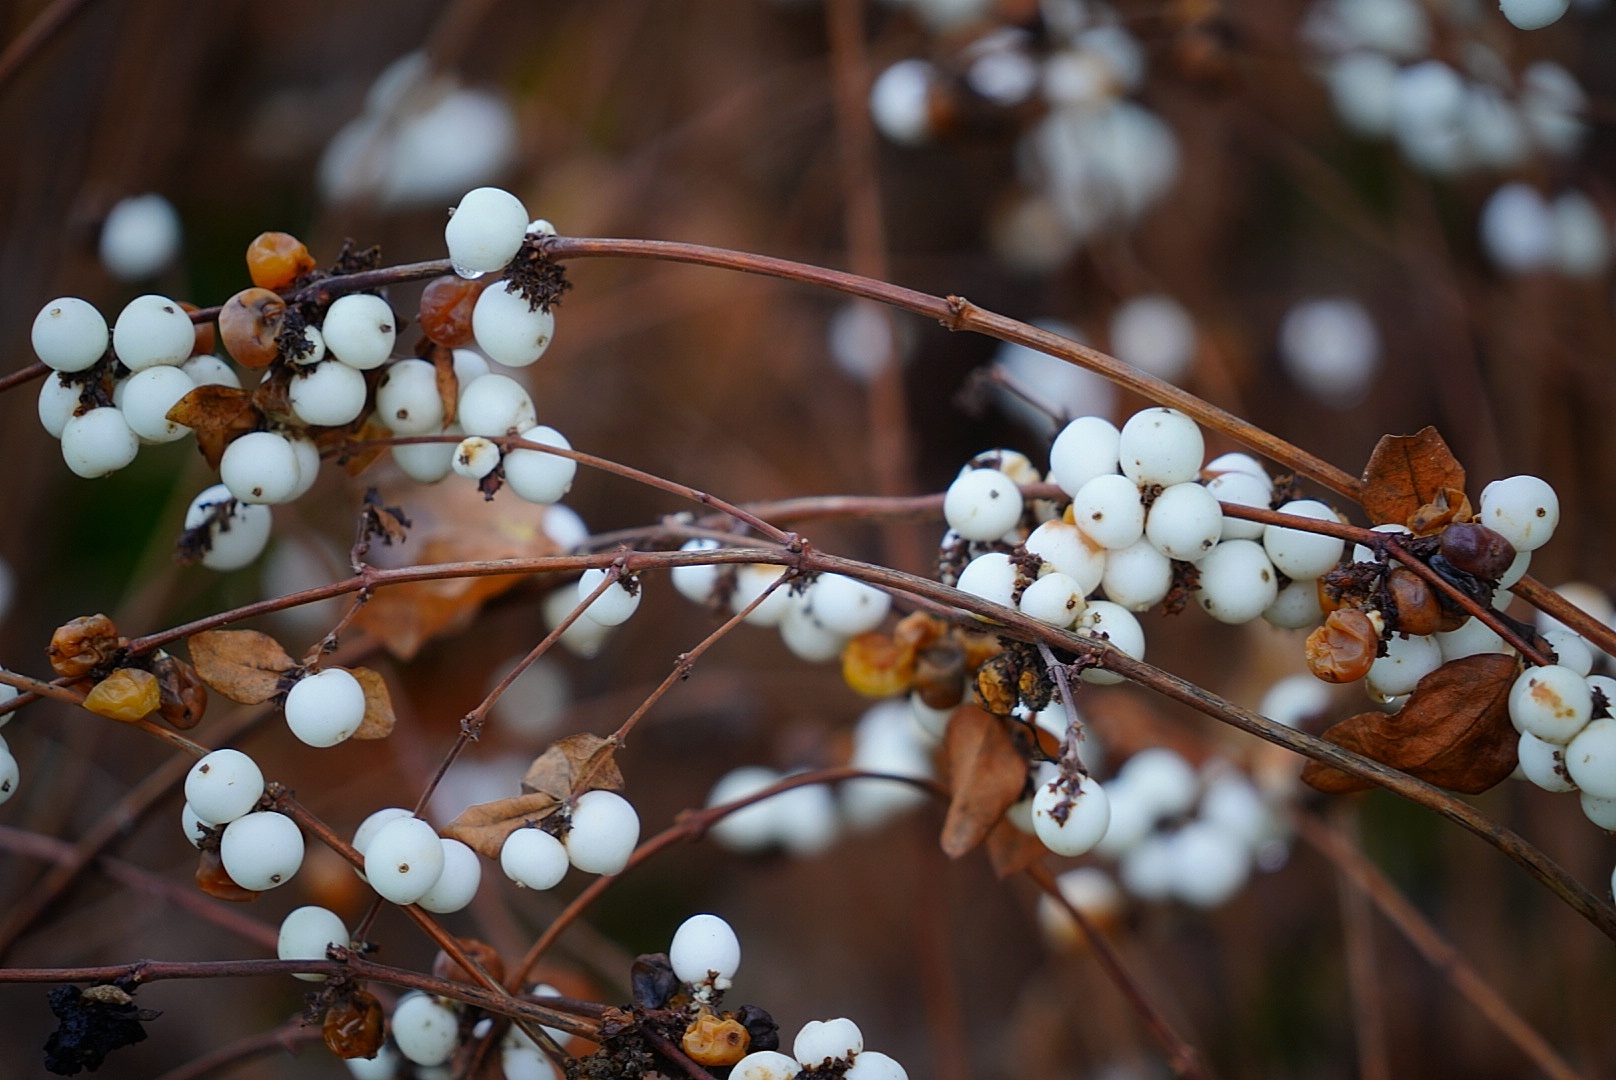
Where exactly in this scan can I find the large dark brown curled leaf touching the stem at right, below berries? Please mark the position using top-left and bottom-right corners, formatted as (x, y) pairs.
(1302, 653), (1519, 795)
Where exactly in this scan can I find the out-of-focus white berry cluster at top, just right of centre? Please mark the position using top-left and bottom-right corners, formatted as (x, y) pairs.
(869, 3), (1180, 270)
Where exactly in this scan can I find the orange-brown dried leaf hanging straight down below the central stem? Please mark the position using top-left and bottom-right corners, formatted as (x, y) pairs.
(942, 705), (1026, 859)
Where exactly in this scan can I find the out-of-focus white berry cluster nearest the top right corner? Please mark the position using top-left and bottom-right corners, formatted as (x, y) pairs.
(1302, 0), (1587, 176)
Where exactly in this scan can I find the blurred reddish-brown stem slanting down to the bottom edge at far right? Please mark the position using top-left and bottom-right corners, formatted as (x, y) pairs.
(1291, 813), (1579, 1080)
